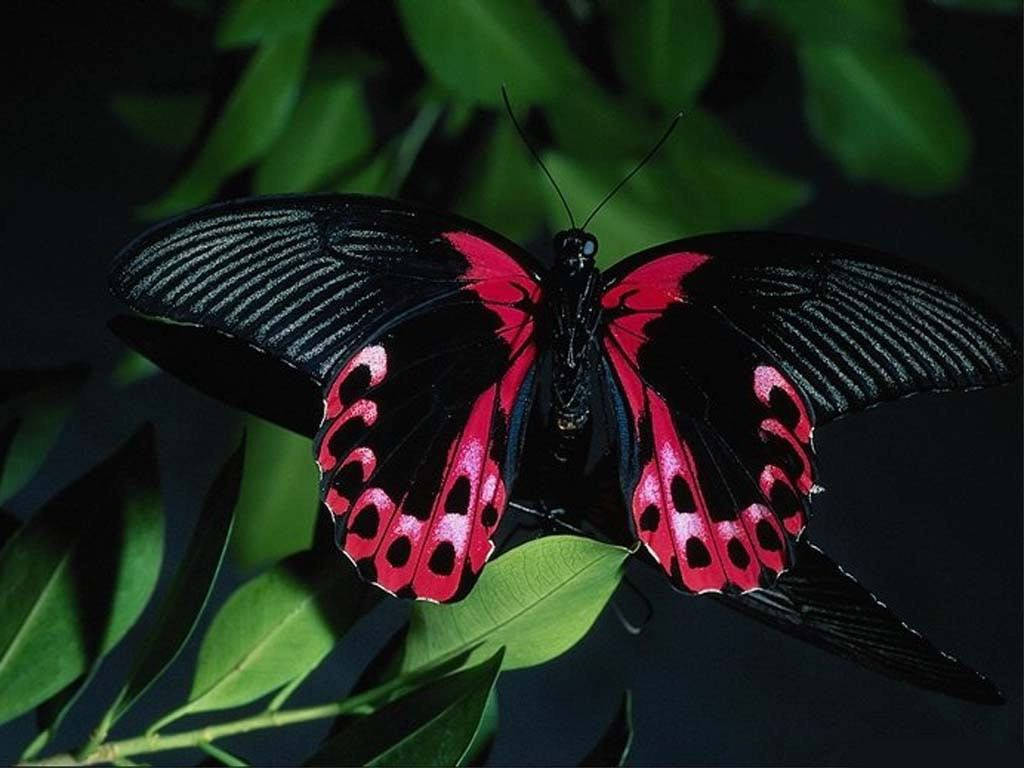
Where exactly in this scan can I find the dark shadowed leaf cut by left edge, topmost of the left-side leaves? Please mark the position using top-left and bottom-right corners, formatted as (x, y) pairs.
(0, 366), (88, 503)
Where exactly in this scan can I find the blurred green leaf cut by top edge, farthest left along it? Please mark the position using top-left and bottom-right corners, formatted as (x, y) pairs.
(217, 0), (334, 48)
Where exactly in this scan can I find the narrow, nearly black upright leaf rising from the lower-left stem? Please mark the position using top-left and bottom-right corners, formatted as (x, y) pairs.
(101, 439), (245, 733)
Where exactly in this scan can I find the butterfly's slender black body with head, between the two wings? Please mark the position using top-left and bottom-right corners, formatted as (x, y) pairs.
(542, 229), (601, 438)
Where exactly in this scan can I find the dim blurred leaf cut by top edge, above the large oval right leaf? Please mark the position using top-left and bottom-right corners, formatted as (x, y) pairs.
(742, 0), (906, 47)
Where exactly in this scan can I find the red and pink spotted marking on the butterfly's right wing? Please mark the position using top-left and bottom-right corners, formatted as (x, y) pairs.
(602, 253), (813, 593)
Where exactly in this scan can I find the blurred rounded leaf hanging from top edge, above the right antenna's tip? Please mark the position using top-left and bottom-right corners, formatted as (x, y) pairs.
(608, 0), (722, 113)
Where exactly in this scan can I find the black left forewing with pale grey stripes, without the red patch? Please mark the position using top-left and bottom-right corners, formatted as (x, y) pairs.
(110, 196), (540, 384)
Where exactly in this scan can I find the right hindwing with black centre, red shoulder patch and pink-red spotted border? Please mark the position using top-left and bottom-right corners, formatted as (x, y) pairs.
(602, 251), (813, 592)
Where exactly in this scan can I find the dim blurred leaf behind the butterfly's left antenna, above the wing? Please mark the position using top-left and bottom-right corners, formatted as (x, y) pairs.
(458, 120), (547, 241)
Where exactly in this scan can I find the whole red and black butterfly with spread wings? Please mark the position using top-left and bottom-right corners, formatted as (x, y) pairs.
(111, 196), (1020, 700)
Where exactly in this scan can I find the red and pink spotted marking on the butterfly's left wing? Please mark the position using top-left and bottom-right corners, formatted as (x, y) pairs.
(316, 232), (540, 602)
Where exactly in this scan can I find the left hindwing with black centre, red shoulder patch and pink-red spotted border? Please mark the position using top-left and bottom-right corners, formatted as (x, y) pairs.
(314, 231), (540, 601)
